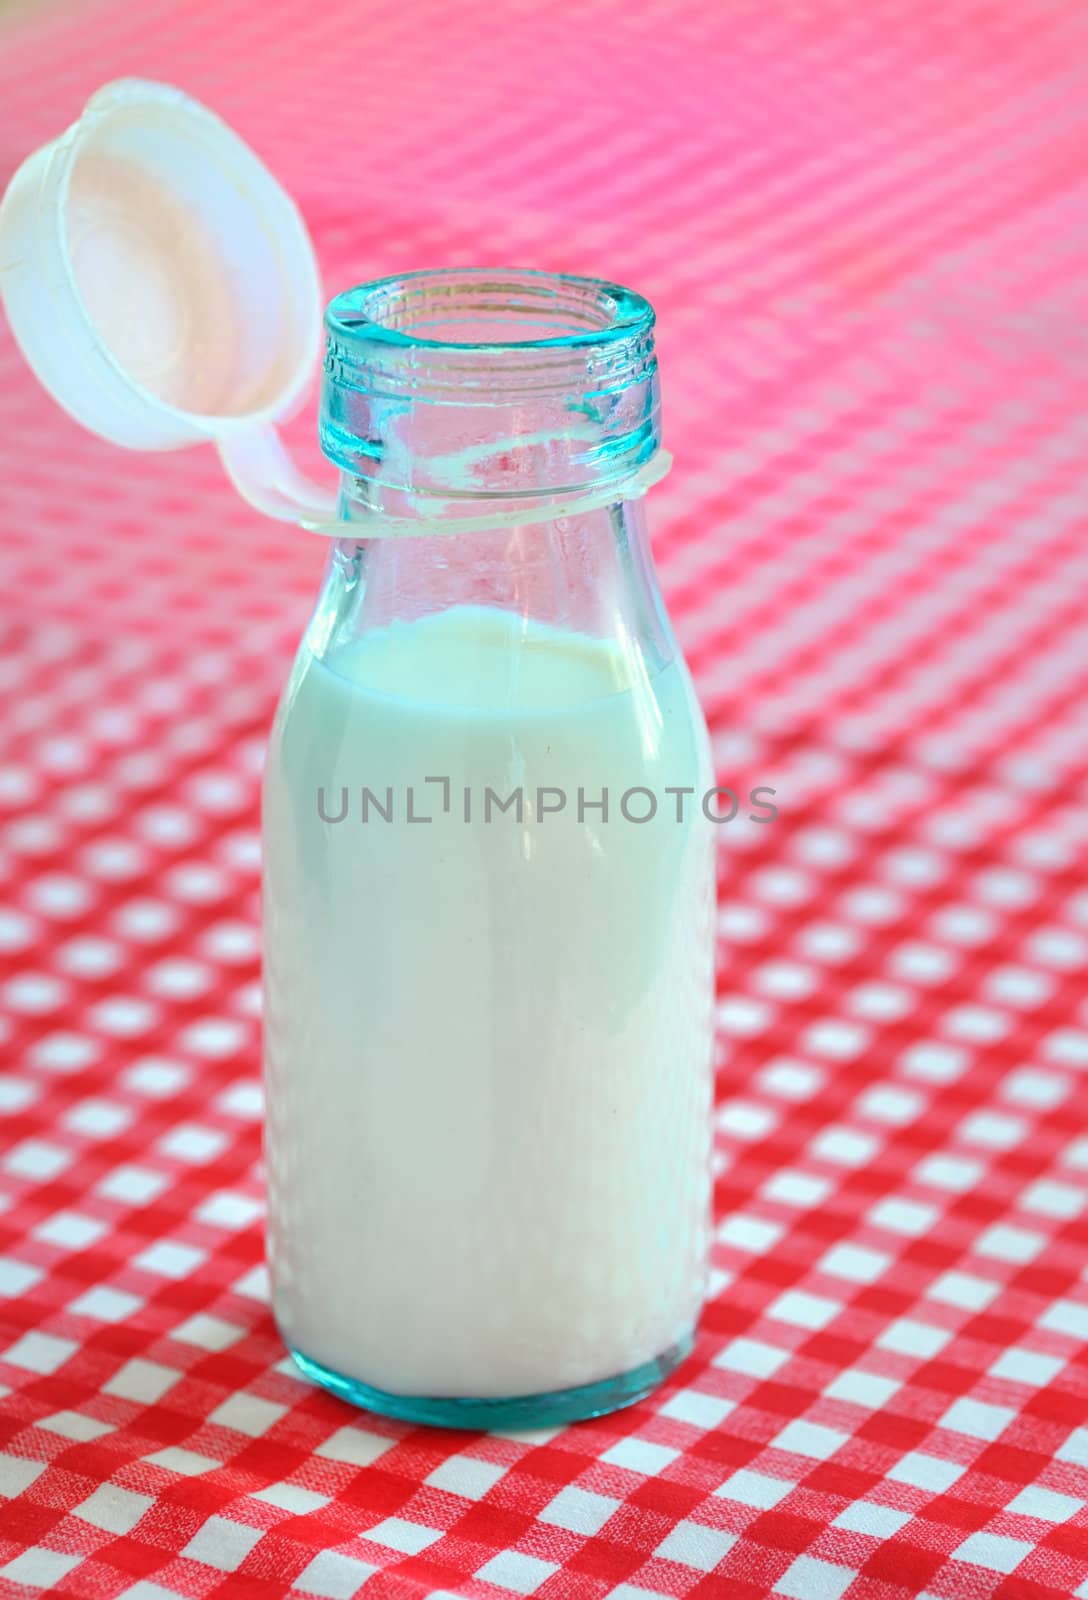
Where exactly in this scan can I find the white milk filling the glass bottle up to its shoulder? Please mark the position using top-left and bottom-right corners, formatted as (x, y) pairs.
(264, 606), (712, 1398)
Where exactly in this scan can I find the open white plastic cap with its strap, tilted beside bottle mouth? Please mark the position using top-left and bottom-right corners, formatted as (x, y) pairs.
(0, 78), (334, 522)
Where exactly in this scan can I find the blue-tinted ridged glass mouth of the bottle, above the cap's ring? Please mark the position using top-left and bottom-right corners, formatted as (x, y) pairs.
(322, 267), (659, 514)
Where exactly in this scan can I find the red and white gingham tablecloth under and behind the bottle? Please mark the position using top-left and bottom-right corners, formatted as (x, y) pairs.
(0, 0), (1088, 1600)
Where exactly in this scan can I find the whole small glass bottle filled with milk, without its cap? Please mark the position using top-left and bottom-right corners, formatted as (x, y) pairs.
(264, 272), (714, 1427)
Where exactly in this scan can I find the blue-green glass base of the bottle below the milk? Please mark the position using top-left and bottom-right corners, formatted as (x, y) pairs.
(291, 1333), (694, 1432)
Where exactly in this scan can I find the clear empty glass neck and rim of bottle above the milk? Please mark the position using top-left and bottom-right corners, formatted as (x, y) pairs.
(310, 269), (674, 672)
